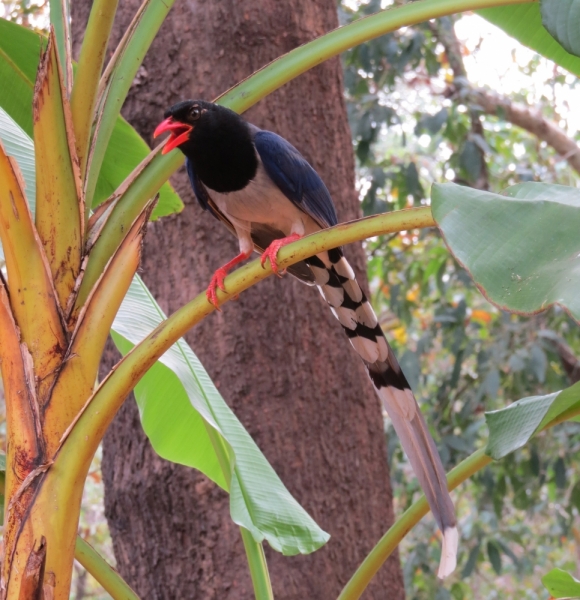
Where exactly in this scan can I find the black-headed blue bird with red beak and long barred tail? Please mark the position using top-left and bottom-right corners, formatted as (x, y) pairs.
(153, 100), (458, 578)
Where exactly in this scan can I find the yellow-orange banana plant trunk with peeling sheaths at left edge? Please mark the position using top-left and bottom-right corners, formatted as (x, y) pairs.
(0, 28), (153, 600)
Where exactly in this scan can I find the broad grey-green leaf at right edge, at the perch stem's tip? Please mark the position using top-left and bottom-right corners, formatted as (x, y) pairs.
(432, 183), (580, 320)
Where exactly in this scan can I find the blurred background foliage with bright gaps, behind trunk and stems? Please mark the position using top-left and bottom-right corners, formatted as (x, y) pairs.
(0, 0), (580, 600)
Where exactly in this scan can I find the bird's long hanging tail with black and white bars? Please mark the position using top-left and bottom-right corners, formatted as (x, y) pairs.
(306, 249), (458, 578)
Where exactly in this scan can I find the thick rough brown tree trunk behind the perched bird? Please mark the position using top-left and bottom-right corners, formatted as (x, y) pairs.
(73, 0), (404, 600)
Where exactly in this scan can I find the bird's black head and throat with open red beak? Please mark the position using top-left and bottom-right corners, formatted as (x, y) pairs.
(153, 100), (258, 192)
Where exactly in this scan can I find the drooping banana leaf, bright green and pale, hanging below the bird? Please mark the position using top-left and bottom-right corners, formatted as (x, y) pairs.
(113, 278), (329, 555)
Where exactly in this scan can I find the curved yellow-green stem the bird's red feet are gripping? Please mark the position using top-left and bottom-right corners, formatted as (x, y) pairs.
(27, 208), (434, 568)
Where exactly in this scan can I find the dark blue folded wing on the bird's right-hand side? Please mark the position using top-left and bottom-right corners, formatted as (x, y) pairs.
(254, 131), (338, 227)
